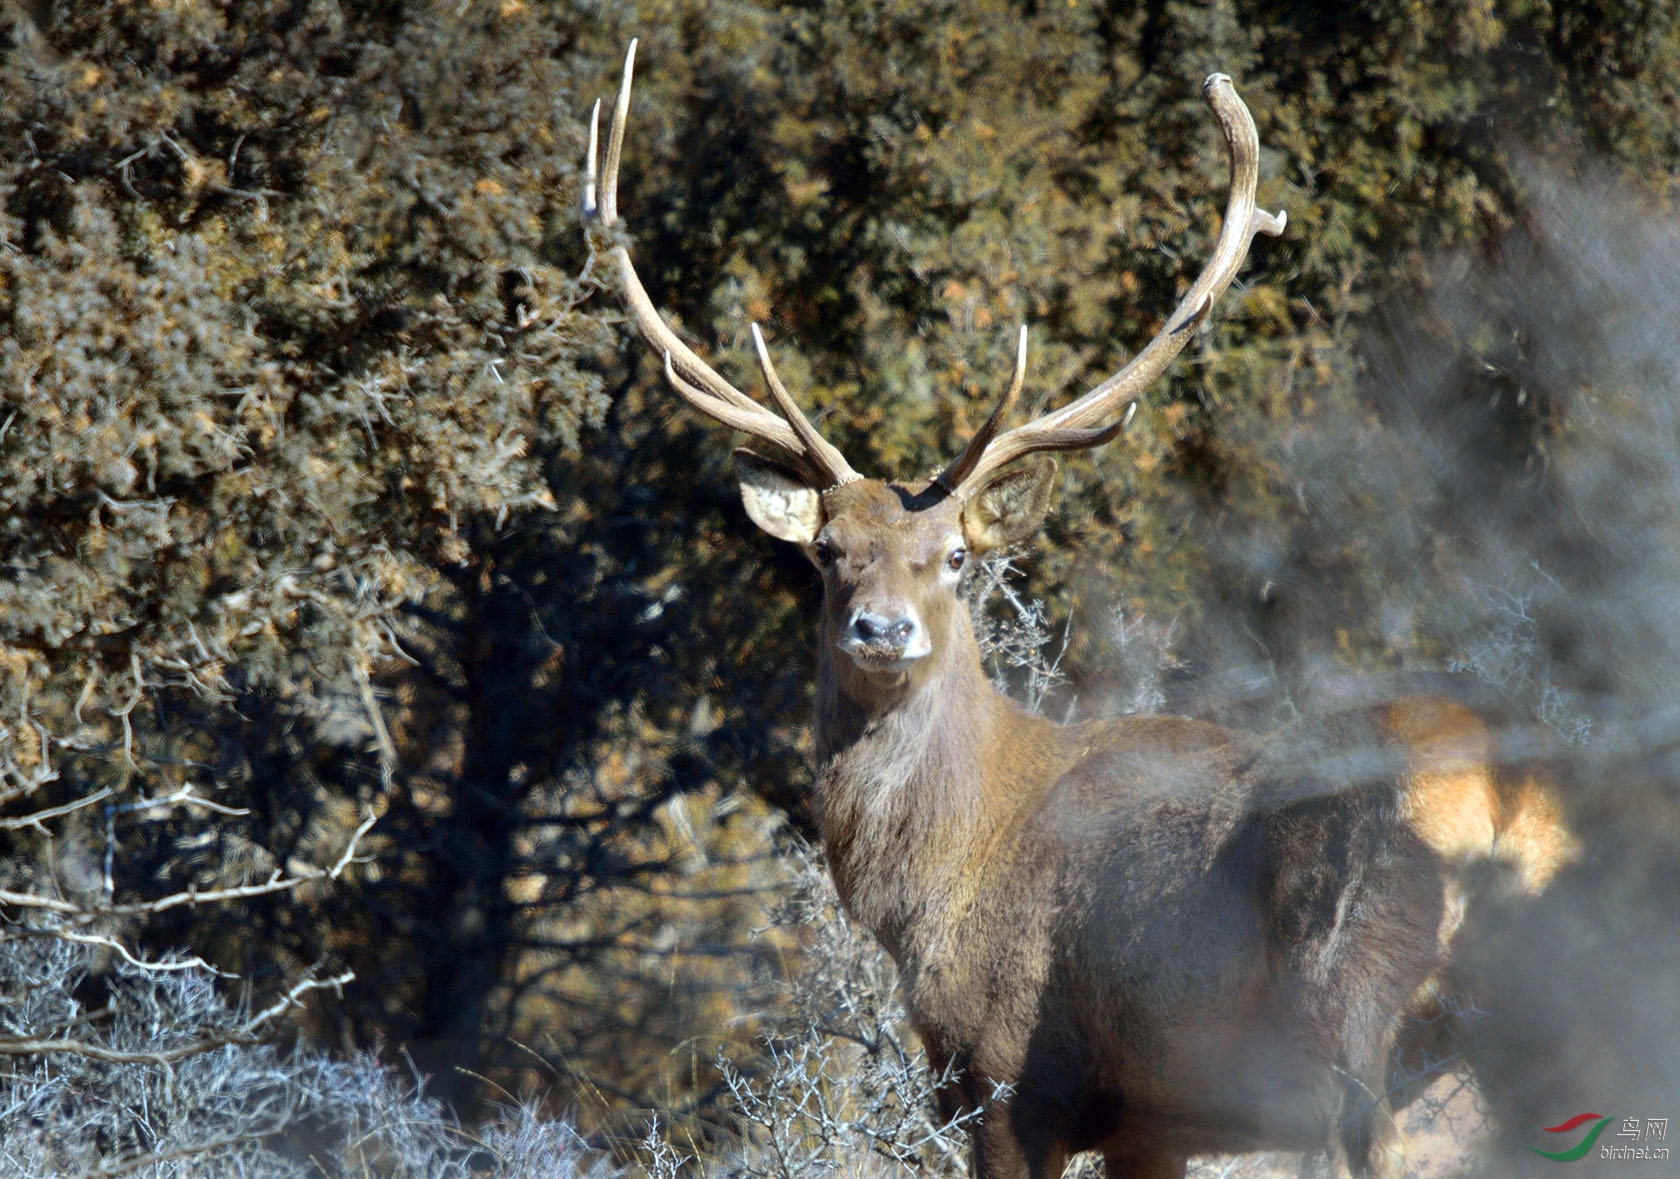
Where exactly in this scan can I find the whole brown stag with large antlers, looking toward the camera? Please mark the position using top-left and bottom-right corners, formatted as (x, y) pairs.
(583, 44), (1562, 1179)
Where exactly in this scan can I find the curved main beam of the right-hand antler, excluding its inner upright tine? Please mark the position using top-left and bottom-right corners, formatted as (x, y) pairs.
(953, 74), (1287, 495)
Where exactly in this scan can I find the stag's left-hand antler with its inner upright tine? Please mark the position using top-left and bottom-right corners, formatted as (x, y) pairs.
(583, 40), (862, 485)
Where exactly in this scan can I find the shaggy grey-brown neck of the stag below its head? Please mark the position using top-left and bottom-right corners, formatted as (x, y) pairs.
(815, 618), (1057, 971)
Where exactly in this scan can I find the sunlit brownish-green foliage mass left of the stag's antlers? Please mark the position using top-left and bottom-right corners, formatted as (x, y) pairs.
(0, 3), (606, 738)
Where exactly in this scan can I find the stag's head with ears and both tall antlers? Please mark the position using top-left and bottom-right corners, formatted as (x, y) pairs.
(583, 42), (1285, 712)
